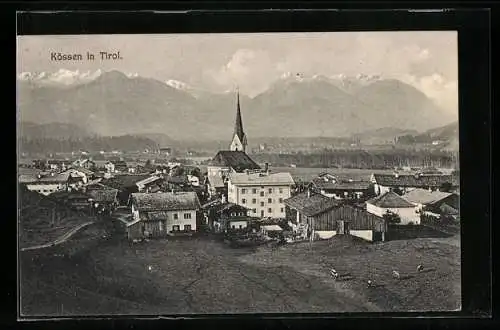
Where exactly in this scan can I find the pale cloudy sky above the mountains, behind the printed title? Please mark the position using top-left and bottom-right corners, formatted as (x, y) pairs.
(17, 31), (458, 114)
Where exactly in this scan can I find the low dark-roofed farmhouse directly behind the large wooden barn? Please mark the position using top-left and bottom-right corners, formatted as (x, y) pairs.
(309, 173), (370, 199)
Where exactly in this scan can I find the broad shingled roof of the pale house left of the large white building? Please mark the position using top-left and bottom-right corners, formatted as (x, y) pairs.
(130, 191), (200, 212)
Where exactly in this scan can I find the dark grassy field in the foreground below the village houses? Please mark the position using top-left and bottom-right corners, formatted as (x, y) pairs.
(20, 222), (460, 317)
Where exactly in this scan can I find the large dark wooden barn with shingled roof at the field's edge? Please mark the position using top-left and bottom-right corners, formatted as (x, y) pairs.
(285, 190), (387, 241)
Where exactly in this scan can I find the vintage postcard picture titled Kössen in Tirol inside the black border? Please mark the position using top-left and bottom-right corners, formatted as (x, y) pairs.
(17, 31), (461, 318)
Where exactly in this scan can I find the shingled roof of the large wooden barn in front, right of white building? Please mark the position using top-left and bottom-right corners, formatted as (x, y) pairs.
(283, 192), (342, 217)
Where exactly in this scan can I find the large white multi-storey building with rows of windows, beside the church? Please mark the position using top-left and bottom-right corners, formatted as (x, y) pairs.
(228, 172), (295, 218)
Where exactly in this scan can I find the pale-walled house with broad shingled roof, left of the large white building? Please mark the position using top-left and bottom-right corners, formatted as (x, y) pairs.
(127, 192), (200, 239)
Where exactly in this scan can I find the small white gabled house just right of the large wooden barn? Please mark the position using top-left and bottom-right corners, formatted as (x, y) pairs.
(366, 191), (420, 225)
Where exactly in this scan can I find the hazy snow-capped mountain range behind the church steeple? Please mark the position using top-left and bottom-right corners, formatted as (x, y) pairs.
(18, 71), (456, 142)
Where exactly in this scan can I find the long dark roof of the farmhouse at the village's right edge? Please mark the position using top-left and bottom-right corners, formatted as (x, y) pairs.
(373, 174), (459, 188)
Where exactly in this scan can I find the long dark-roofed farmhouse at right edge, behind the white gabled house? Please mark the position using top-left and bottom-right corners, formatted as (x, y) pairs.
(371, 173), (459, 195)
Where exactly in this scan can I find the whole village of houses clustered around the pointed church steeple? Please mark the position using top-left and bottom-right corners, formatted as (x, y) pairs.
(19, 90), (460, 312)
